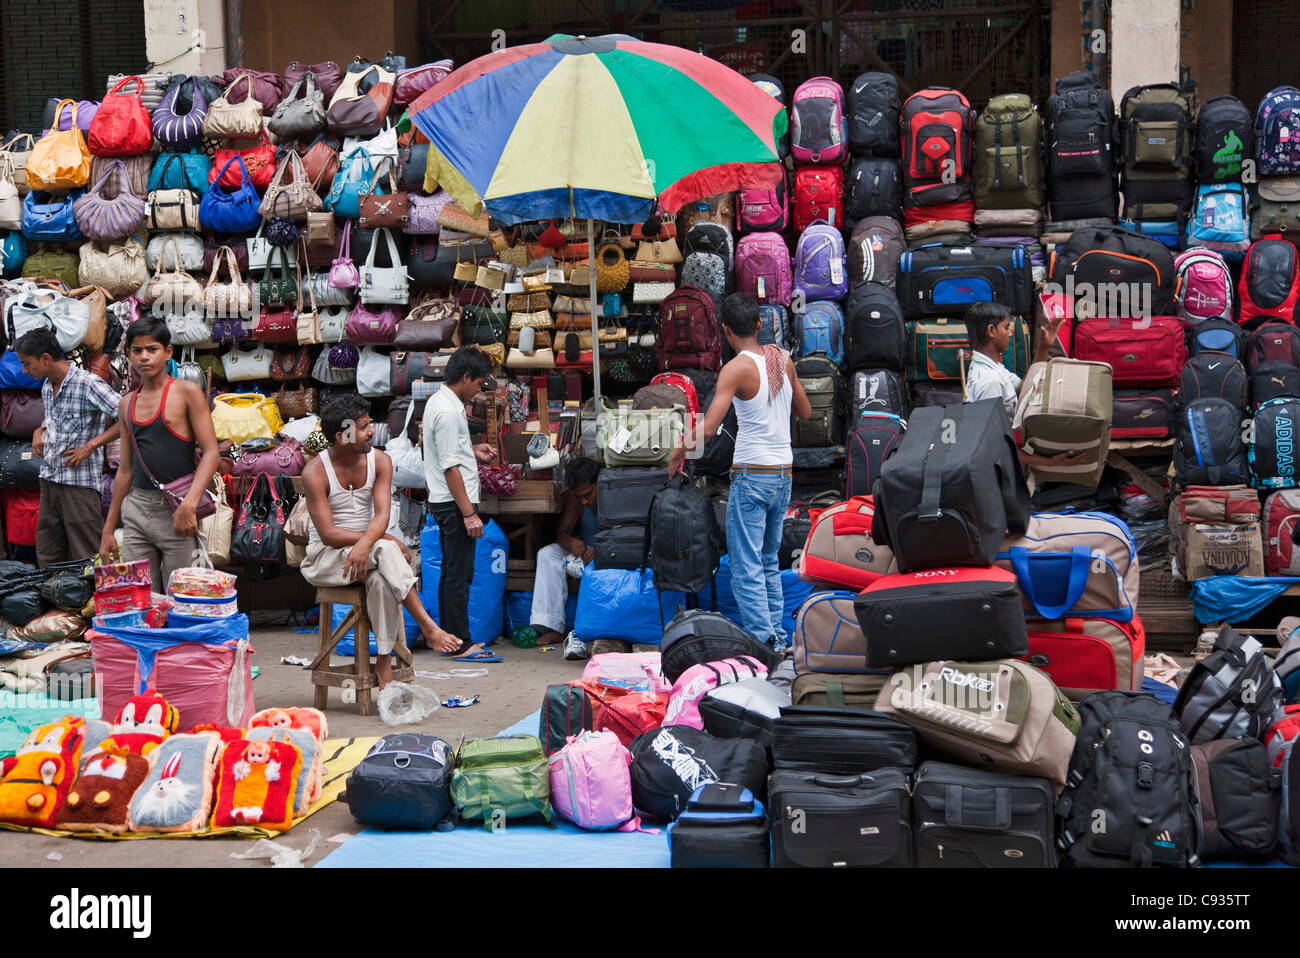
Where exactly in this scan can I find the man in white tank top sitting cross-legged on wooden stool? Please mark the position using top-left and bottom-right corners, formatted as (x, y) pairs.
(302, 394), (460, 689)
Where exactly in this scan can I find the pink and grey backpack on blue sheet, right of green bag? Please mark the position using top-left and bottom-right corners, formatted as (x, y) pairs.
(550, 732), (641, 832)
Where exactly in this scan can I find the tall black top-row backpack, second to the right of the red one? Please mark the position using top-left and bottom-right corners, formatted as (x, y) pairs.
(1043, 70), (1119, 221)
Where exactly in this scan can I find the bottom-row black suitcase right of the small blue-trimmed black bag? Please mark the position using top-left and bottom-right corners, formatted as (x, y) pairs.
(767, 768), (914, 868)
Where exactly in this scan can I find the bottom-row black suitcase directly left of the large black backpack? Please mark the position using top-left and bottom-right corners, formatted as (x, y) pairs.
(911, 762), (1057, 868)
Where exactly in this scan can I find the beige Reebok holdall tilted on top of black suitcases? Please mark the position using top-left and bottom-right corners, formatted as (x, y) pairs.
(876, 659), (1079, 790)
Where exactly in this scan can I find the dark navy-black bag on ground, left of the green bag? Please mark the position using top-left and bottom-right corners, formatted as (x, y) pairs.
(346, 732), (455, 828)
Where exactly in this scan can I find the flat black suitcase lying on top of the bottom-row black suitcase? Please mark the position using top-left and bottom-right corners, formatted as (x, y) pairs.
(772, 706), (917, 775)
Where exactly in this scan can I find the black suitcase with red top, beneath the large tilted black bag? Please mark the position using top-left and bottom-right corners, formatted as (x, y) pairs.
(853, 565), (1028, 668)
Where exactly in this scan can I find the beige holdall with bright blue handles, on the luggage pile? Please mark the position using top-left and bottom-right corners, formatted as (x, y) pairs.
(995, 512), (1139, 623)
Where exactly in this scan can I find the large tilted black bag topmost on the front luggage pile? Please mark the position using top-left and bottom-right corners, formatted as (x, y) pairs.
(871, 399), (1030, 572)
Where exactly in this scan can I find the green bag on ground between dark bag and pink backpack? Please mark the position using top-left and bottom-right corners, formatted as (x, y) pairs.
(451, 736), (551, 829)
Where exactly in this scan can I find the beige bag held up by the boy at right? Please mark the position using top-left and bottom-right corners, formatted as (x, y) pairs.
(1011, 359), (1114, 486)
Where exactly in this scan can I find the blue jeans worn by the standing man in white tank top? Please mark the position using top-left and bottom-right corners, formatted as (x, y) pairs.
(727, 467), (790, 645)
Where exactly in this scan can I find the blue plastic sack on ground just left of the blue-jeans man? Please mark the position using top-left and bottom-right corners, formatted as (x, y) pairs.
(573, 569), (686, 645)
